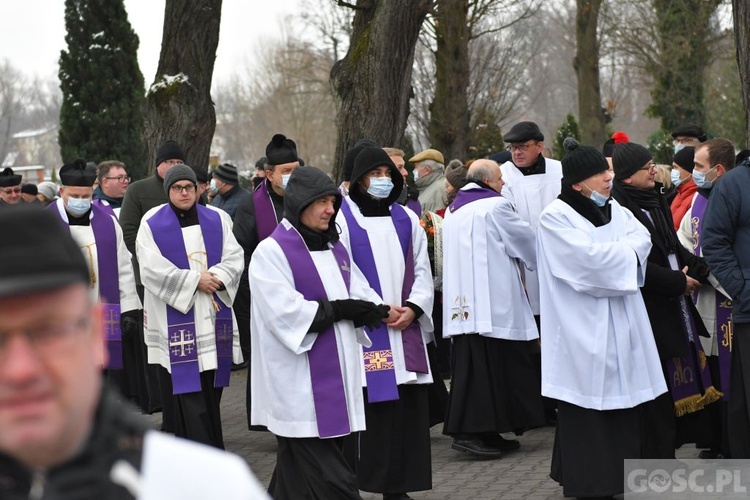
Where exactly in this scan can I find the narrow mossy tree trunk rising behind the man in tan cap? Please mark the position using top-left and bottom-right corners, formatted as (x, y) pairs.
(428, 0), (470, 162)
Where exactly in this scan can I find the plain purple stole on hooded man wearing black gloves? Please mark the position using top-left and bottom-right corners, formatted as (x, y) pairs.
(271, 224), (351, 438)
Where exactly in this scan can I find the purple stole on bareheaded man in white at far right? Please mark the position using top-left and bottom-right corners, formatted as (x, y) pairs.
(690, 193), (733, 401)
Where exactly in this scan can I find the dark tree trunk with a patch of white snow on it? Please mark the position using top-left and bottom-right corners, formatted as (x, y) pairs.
(143, 0), (222, 173)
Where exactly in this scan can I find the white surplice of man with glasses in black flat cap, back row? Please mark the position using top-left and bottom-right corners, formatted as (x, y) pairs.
(500, 158), (562, 314)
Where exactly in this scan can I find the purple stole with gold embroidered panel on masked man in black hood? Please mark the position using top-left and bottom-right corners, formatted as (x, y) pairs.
(341, 200), (429, 403)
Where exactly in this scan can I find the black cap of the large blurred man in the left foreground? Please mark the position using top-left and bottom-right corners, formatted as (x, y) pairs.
(0, 204), (89, 297)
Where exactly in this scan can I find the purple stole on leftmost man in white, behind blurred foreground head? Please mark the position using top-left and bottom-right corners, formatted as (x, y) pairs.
(49, 203), (124, 370)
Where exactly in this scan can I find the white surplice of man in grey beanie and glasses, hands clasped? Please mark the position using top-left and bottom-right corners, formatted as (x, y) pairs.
(135, 205), (245, 373)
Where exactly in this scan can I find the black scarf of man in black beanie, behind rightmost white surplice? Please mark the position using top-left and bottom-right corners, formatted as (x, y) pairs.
(614, 182), (680, 254)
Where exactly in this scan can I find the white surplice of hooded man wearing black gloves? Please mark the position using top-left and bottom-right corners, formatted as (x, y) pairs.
(253, 219), (380, 438)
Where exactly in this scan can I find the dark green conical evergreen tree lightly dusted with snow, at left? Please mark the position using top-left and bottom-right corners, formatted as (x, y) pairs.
(59, 0), (146, 179)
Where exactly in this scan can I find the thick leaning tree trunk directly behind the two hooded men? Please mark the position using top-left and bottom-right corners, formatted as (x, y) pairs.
(331, 0), (432, 179)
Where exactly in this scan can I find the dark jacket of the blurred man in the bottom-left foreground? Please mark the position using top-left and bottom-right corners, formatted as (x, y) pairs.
(0, 389), (149, 500)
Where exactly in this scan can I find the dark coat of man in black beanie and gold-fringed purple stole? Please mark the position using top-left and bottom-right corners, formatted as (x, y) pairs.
(612, 182), (708, 359)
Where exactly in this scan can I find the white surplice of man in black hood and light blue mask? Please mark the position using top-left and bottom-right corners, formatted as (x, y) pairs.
(336, 197), (435, 384)
